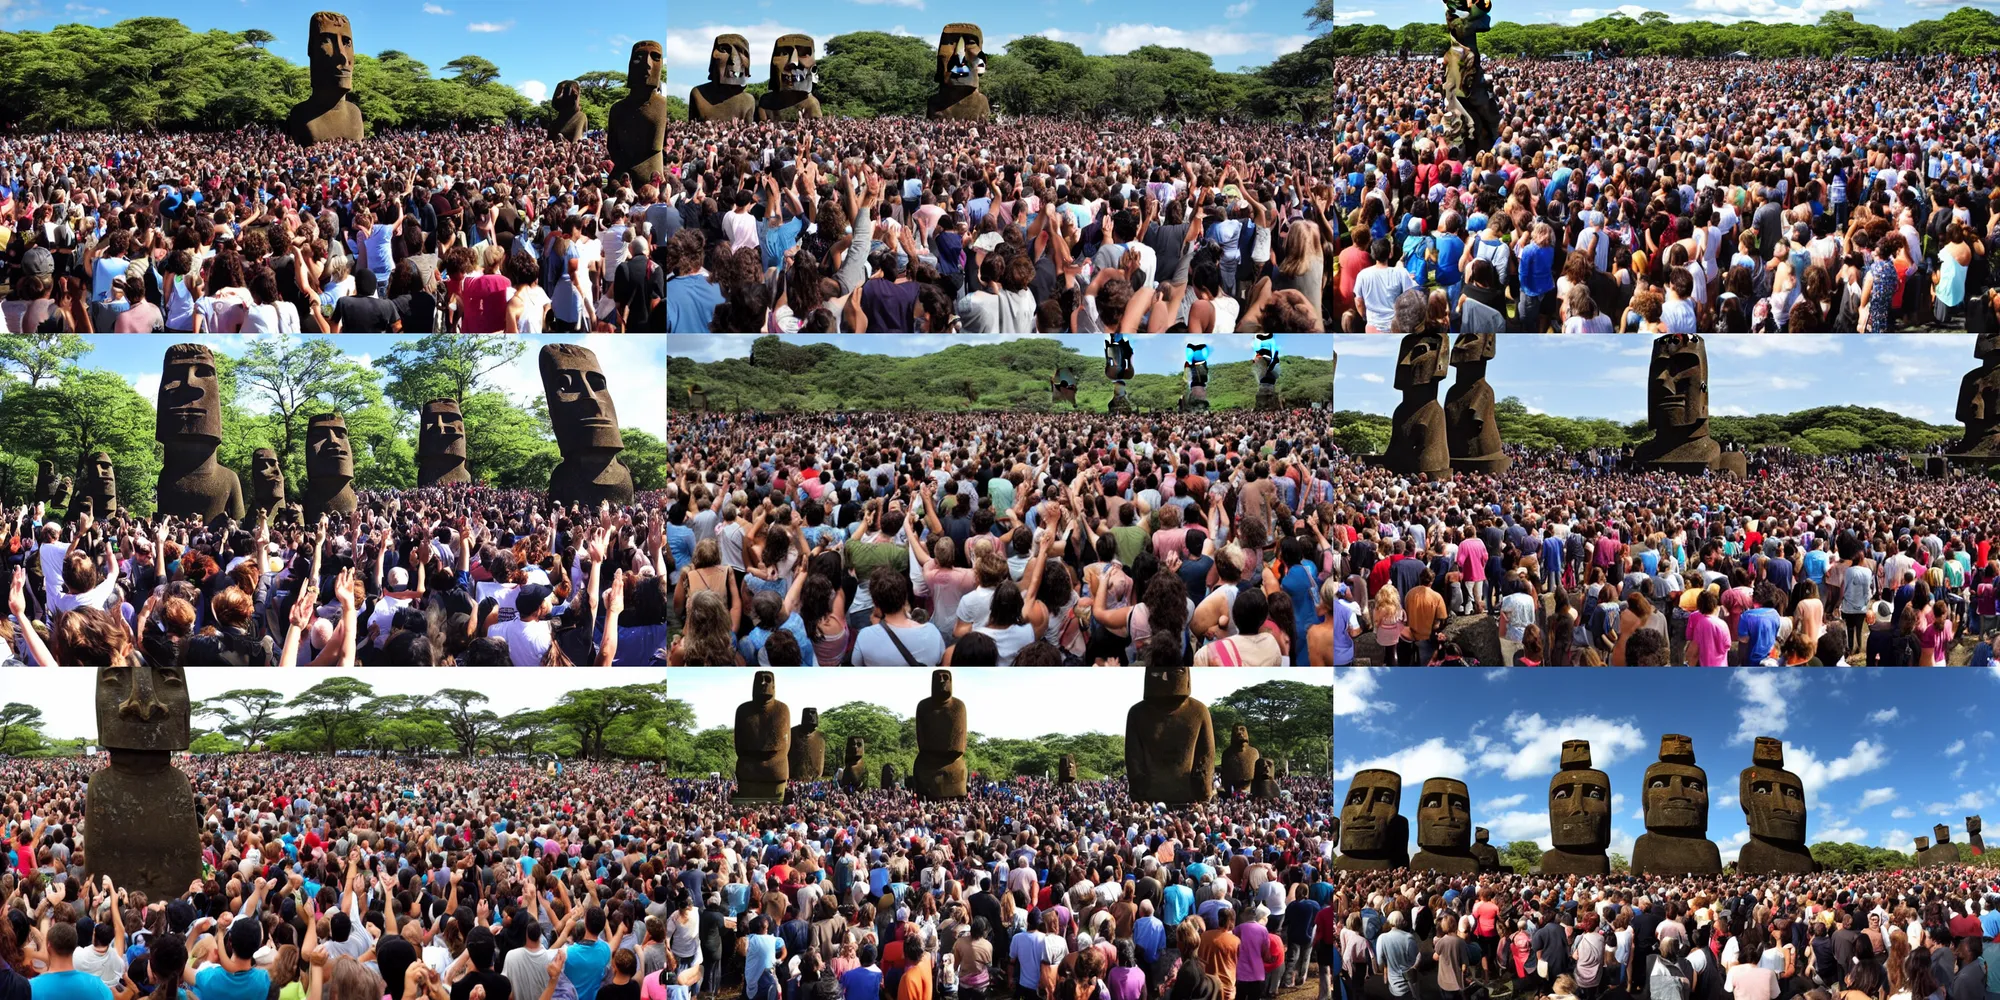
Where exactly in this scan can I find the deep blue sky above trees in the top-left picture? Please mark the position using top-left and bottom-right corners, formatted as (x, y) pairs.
(0, 0), (664, 100)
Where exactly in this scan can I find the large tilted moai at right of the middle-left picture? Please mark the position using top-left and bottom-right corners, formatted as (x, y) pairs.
(538, 344), (632, 508)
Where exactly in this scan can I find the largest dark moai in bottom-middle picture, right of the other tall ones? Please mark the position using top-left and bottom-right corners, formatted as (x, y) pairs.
(1126, 666), (1216, 806)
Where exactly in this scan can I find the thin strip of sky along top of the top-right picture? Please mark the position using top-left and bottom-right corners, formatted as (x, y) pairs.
(1334, 0), (1944, 28)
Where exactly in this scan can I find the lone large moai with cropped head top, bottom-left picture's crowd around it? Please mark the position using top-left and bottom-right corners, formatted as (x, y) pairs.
(84, 666), (202, 900)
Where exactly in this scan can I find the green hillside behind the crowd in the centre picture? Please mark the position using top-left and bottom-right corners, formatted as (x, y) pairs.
(666, 336), (1334, 412)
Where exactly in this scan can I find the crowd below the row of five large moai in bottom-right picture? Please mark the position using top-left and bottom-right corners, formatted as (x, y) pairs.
(1330, 864), (2000, 1000)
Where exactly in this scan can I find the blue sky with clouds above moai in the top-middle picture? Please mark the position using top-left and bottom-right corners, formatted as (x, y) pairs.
(666, 0), (1312, 96)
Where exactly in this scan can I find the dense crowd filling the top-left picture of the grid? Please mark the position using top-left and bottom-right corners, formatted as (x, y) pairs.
(0, 128), (680, 334)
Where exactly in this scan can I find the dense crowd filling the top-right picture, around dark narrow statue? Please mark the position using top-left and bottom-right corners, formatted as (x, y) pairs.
(1324, 54), (2000, 332)
